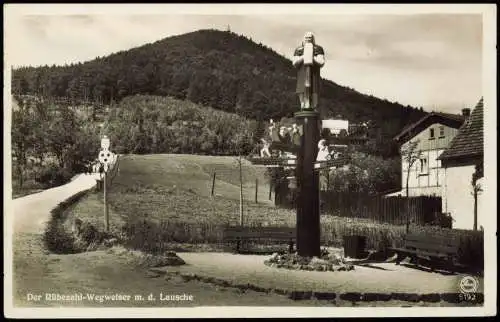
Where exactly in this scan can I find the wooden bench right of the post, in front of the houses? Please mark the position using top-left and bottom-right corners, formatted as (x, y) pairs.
(389, 233), (461, 273)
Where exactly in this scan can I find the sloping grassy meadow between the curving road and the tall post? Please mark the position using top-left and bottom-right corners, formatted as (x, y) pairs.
(109, 154), (290, 224)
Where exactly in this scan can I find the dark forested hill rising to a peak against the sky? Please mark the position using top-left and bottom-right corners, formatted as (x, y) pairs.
(12, 30), (425, 138)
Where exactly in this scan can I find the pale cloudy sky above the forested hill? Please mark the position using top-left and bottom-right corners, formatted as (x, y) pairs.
(2, 5), (483, 113)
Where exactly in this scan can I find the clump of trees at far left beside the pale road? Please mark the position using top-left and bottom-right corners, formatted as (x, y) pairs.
(11, 97), (100, 189)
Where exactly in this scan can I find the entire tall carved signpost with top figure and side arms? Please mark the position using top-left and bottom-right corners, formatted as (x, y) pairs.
(249, 32), (364, 257)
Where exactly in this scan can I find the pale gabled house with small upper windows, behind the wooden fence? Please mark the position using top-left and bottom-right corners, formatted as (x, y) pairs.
(386, 111), (467, 197)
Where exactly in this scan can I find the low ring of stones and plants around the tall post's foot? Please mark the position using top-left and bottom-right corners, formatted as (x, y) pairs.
(264, 251), (354, 272)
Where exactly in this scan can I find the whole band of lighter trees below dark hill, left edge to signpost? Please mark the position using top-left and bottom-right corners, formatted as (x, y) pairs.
(11, 95), (258, 192)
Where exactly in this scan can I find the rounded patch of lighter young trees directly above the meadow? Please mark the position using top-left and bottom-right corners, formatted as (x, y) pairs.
(103, 95), (258, 155)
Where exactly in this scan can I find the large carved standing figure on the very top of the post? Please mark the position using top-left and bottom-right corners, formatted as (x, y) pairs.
(293, 32), (325, 110)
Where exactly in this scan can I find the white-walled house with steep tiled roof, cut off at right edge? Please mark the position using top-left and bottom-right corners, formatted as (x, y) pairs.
(439, 98), (484, 229)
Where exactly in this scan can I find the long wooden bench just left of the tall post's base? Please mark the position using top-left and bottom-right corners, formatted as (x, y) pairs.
(222, 226), (297, 253)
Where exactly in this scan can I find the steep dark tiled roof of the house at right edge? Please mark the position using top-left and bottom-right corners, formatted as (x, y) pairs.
(438, 98), (483, 160)
